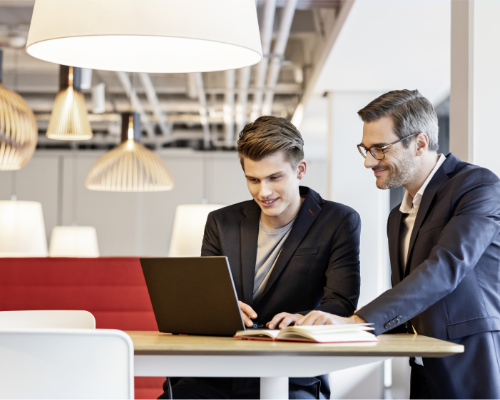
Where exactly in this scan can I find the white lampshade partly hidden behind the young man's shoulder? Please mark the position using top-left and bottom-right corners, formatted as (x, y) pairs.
(168, 204), (224, 257)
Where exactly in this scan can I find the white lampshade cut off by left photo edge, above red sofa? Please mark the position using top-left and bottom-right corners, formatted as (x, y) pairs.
(0, 201), (47, 257)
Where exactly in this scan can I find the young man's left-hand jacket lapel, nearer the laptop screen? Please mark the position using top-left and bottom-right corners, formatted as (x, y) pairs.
(240, 202), (260, 306)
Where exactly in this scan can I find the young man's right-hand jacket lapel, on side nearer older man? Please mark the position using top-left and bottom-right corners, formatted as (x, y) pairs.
(261, 189), (321, 299)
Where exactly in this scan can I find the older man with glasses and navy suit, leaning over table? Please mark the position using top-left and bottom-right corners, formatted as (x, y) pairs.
(297, 90), (500, 400)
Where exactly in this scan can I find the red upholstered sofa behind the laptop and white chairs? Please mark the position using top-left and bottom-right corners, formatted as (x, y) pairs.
(0, 257), (164, 400)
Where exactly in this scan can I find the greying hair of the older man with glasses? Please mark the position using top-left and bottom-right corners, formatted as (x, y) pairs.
(358, 89), (439, 151)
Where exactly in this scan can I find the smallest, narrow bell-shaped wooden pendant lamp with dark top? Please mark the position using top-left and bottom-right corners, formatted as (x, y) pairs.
(46, 65), (92, 140)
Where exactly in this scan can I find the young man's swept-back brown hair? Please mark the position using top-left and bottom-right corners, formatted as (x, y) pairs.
(238, 115), (304, 168)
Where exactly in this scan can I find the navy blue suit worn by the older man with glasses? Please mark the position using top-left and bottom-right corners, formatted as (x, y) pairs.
(357, 154), (500, 400)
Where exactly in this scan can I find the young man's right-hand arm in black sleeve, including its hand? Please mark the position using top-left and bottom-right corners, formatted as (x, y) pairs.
(267, 212), (361, 329)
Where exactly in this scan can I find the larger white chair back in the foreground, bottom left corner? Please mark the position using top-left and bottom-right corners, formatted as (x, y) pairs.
(0, 329), (134, 400)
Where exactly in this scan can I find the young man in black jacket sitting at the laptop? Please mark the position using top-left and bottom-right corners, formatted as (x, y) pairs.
(160, 116), (361, 400)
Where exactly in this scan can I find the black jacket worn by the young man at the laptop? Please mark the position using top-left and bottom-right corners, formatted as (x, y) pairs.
(201, 187), (361, 396)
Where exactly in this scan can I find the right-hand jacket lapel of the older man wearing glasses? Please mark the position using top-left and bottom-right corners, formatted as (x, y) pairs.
(404, 153), (459, 277)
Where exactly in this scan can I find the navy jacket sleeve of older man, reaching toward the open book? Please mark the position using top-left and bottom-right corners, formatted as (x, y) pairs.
(356, 180), (500, 335)
